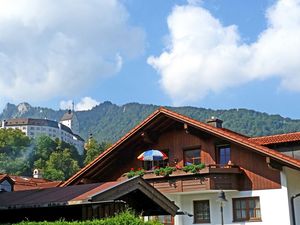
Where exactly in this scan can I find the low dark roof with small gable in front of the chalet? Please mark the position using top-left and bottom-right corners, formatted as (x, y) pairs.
(0, 177), (179, 219)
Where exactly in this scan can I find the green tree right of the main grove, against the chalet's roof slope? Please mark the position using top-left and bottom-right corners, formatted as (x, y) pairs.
(84, 138), (110, 165)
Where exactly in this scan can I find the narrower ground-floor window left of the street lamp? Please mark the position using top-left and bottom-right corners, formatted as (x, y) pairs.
(194, 200), (210, 223)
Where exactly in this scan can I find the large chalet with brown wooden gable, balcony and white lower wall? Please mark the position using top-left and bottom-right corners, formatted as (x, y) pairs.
(62, 108), (300, 225)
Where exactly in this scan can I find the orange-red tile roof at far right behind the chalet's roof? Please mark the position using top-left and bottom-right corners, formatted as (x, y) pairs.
(249, 132), (300, 145)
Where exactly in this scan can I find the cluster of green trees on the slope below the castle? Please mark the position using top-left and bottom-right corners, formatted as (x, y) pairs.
(0, 129), (109, 180)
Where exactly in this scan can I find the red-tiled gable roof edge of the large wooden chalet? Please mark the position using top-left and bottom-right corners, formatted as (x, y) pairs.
(62, 107), (300, 186)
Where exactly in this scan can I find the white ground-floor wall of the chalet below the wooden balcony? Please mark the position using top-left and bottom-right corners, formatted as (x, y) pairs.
(167, 187), (290, 225)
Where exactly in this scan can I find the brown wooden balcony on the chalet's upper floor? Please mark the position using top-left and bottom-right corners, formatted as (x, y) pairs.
(143, 165), (242, 193)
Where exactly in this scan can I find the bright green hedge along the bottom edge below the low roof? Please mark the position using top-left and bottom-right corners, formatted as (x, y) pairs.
(11, 210), (162, 225)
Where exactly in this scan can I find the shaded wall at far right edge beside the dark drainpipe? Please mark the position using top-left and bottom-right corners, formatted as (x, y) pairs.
(283, 167), (300, 225)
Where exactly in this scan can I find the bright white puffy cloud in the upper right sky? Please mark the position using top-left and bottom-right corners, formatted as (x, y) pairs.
(148, 0), (300, 105)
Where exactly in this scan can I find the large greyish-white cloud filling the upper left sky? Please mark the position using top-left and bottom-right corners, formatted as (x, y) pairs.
(0, 0), (145, 101)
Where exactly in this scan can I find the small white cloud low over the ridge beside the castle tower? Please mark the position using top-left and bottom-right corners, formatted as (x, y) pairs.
(59, 97), (100, 111)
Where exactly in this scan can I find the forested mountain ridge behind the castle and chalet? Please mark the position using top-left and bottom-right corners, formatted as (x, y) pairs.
(0, 101), (300, 143)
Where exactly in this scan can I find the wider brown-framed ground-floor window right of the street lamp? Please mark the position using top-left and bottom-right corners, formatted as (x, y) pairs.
(232, 197), (261, 221)
